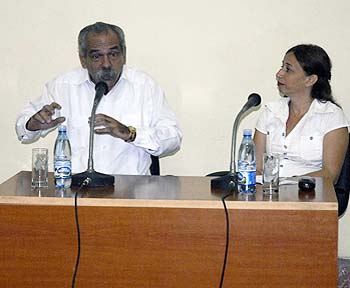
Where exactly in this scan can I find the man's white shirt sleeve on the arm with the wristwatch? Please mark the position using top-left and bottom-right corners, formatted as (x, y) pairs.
(132, 85), (182, 156)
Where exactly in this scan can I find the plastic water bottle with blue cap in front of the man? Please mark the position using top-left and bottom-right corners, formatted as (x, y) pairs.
(54, 125), (72, 188)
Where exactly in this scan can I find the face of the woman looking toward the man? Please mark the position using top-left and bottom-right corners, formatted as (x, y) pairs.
(276, 52), (312, 96)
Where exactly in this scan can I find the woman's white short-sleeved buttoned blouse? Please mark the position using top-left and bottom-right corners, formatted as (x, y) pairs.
(256, 97), (349, 177)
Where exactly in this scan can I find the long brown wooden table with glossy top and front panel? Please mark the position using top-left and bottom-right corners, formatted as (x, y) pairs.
(0, 171), (338, 288)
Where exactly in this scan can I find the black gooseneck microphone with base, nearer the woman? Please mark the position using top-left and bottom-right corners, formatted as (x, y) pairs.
(211, 93), (261, 192)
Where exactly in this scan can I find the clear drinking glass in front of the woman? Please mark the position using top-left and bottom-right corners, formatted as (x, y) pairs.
(262, 153), (280, 194)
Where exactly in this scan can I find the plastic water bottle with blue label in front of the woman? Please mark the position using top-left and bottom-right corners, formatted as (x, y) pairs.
(238, 129), (256, 194)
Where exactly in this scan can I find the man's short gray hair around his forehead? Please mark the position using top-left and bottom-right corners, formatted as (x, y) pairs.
(78, 22), (126, 57)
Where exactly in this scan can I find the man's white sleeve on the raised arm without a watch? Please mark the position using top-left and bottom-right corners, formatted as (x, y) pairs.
(16, 85), (54, 143)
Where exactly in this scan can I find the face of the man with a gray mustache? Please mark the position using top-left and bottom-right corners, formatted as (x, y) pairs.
(79, 31), (125, 90)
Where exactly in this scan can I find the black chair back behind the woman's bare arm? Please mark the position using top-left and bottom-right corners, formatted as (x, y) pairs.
(334, 136), (350, 216)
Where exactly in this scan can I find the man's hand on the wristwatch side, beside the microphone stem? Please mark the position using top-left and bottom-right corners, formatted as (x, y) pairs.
(94, 114), (130, 141)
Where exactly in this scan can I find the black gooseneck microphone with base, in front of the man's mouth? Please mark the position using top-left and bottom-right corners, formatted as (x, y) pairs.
(72, 81), (114, 187)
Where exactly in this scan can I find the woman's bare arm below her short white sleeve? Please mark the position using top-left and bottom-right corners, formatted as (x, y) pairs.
(308, 127), (349, 184)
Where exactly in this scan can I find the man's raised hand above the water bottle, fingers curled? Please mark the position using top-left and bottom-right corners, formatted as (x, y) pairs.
(26, 102), (66, 131)
